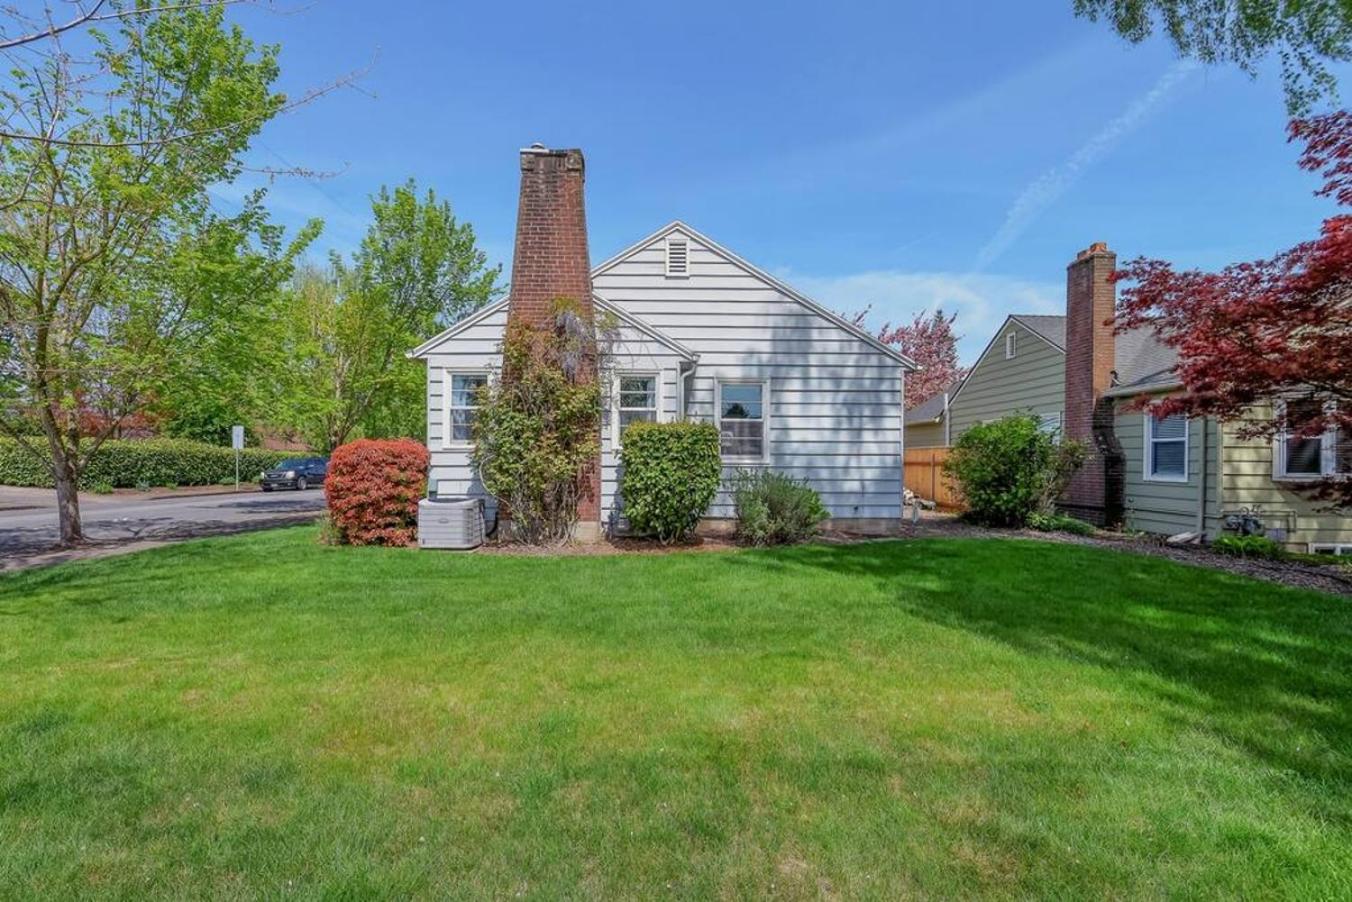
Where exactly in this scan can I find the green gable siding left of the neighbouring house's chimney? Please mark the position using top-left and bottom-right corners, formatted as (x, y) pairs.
(949, 321), (1065, 442)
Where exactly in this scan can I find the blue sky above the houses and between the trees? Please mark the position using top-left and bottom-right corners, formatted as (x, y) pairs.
(222, 0), (1347, 361)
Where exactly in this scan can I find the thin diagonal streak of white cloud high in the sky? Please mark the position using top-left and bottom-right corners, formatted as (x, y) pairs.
(976, 60), (1198, 269)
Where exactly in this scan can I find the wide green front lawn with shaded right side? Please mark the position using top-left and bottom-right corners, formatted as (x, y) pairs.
(0, 529), (1352, 898)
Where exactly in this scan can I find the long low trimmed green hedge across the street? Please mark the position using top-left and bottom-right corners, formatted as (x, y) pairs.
(0, 437), (296, 488)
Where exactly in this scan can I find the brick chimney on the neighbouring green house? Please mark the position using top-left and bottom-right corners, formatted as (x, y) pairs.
(1061, 241), (1122, 525)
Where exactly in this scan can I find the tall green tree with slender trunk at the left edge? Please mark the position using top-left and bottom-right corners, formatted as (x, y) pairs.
(0, 3), (312, 544)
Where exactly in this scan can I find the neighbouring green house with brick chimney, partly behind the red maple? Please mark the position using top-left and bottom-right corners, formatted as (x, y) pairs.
(906, 245), (1352, 556)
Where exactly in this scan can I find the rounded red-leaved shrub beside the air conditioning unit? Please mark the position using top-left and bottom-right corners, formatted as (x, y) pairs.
(324, 438), (427, 545)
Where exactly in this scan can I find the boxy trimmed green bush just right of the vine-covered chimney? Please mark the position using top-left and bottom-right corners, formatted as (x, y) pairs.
(619, 423), (723, 544)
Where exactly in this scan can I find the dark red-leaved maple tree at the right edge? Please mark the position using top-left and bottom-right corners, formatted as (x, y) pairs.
(1115, 110), (1352, 507)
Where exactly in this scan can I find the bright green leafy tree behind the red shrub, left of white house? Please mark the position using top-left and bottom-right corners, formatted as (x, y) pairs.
(274, 180), (502, 450)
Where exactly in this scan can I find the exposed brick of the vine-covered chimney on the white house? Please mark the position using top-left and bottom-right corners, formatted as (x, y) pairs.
(507, 145), (600, 541)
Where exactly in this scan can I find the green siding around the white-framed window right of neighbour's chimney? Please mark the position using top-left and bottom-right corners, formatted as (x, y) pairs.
(1113, 410), (1221, 538)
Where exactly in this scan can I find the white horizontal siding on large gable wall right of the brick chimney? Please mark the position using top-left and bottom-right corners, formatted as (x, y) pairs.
(594, 229), (903, 518)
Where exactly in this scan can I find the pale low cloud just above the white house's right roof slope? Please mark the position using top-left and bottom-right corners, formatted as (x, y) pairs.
(776, 270), (1065, 364)
